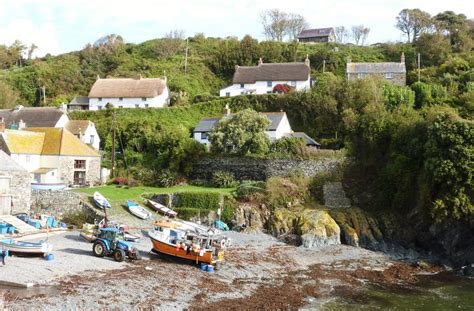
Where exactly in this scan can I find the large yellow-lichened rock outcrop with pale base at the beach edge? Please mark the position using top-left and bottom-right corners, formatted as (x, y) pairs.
(271, 208), (341, 248)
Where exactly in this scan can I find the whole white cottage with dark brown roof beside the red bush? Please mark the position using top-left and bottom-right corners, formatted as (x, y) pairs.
(219, 58), (311, 96)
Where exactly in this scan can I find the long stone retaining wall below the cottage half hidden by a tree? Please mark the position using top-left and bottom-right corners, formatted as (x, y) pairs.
(191, 157), (342, 180)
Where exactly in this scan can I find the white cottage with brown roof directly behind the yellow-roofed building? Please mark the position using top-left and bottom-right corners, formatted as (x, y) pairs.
(0, 105), (100, 150)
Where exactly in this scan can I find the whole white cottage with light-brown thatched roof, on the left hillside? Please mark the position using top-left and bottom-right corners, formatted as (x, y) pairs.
(89, 77), (169, 110)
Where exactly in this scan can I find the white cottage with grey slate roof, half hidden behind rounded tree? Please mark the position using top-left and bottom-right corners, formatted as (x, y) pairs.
(193, 107), (320, 147)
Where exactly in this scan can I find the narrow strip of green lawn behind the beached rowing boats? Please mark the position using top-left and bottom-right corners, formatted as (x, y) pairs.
(74, 185), (235, 205)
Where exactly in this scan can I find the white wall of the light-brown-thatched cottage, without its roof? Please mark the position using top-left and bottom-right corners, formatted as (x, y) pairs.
(89, 87), (169, 110)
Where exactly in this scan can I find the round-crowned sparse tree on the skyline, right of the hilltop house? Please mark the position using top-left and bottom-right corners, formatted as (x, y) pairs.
(396, 9), (433, 43)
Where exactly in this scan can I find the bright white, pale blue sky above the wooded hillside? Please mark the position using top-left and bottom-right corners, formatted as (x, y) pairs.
(0, 0), (474, 56)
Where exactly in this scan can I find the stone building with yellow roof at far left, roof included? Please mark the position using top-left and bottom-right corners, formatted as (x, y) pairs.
(0, 127), (101, 189)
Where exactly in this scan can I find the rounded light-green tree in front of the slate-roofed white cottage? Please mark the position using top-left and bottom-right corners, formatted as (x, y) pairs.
(209, 109), (271, 155)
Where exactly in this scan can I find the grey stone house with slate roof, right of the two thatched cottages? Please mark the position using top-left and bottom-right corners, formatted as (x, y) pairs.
(346, 53), (407, 86)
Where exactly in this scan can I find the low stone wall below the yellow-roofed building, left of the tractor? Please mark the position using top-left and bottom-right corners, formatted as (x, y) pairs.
(31, 190), (88, 219)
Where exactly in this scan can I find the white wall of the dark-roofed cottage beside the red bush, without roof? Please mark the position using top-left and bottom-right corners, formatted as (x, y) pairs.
(219, 76), (311, 97)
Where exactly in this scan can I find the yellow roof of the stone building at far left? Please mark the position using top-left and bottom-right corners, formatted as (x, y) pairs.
(2, 127), (100, 157)
